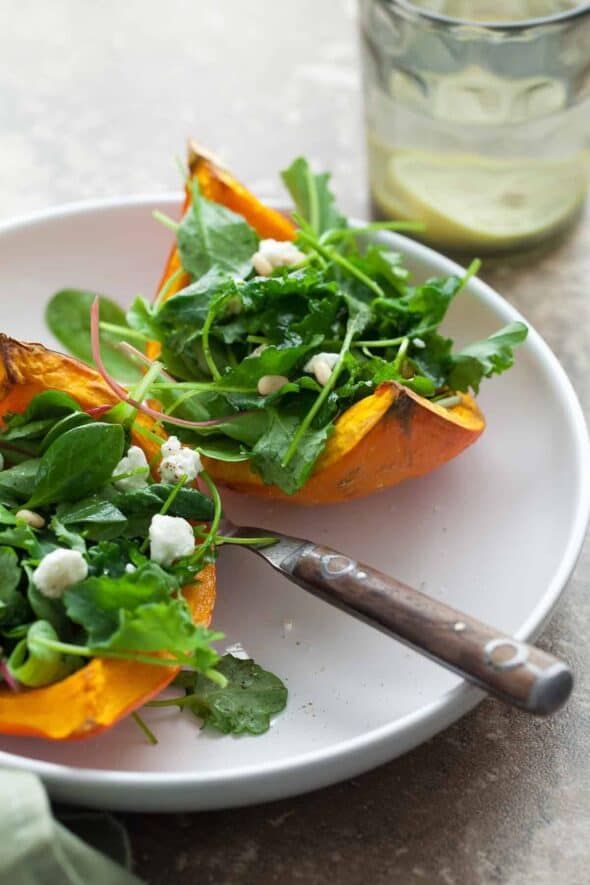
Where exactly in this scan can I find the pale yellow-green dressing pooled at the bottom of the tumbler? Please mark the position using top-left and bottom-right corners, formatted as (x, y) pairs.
(373, 151), (587, 252)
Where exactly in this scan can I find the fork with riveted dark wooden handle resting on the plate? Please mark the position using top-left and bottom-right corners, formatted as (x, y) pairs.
(221, 518), (573, 715)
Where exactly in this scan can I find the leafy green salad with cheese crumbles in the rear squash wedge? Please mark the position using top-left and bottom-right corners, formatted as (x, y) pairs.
(47, 158), (527, 494)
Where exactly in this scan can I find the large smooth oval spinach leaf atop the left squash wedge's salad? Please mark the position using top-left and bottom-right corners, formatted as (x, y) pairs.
(28, 421), (125, 507)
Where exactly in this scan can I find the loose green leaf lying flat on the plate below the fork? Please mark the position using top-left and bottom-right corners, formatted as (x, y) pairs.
(175, 654), (288, 734)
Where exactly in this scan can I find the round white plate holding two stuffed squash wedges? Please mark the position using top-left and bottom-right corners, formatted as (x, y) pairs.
(0, 196), (590, 811)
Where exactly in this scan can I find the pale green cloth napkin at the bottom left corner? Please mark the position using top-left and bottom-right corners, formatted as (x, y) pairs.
(0, 770), (141, 885)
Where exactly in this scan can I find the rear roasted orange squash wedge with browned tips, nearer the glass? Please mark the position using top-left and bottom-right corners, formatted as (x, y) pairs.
(149, 142), (485, 505)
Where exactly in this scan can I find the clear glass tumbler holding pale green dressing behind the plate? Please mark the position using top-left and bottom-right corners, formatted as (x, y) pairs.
(360, 0), (590, 255)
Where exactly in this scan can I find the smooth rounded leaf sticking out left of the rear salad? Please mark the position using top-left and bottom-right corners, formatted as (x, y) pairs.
(45, 289), (142, 381)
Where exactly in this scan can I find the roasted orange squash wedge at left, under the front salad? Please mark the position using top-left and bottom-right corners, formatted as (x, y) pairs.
(0, 334), (215, 740)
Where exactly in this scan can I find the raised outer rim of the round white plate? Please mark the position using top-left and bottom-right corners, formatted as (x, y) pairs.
(0, 199), (590, 807)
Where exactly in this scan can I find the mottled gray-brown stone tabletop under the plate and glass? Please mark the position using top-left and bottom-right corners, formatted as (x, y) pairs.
(0, 0), (590, 885)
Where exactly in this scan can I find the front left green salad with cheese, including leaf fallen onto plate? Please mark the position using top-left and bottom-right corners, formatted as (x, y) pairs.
(0, 388), (287, 733)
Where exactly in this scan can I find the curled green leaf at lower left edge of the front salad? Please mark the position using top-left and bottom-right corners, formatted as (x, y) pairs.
(8, 621), (82, 688)
